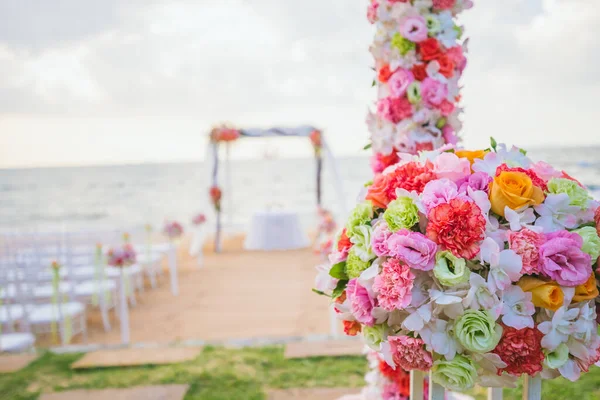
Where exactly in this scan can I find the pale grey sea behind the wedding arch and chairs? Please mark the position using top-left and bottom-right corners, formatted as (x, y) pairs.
(0, 147), (600, 232)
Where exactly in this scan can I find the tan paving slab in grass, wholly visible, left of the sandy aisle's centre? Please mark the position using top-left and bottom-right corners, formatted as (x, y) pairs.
(71, 347), (202, 369)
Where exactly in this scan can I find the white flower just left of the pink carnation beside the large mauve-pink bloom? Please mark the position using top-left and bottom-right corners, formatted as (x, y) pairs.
(480, 238), (523, 291)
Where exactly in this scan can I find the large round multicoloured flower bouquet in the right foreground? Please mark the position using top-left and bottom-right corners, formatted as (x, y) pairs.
(317, 140), (600, 391)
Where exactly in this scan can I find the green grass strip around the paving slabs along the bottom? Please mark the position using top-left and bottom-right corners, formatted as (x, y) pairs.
(0, 347), (600, 400)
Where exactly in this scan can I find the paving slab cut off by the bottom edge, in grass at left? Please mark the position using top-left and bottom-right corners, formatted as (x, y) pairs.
(40, 385), (189, 400)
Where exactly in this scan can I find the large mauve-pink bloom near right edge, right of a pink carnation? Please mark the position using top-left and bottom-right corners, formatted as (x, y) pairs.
(539, 231), (592, 287)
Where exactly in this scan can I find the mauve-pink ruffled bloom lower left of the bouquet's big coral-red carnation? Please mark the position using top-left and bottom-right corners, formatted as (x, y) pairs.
(387, 229), (437, 271)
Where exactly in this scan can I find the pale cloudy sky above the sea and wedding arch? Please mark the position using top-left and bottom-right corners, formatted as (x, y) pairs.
(0, 0), (600, 167)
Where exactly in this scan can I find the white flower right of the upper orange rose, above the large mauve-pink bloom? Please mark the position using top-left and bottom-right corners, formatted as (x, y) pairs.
(535, 193), (579, 233)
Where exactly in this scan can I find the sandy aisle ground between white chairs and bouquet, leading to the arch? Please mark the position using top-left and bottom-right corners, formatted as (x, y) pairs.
(38, 236), (336, 346)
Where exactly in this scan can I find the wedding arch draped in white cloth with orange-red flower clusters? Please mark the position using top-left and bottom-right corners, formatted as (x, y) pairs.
(209, 125), (347, 253)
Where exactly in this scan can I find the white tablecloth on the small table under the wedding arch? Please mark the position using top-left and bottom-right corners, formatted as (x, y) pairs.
(244, 211), (309, 250)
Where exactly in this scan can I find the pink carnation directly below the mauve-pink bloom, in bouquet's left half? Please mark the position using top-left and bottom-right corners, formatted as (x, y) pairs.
(372, 258), (415, 311)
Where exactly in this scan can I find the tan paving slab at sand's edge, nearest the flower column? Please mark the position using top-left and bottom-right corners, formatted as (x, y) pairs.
(285, 340), (364, 358)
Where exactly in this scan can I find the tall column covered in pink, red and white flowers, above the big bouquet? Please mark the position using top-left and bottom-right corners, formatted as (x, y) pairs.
(367, 0), (473, 173)
